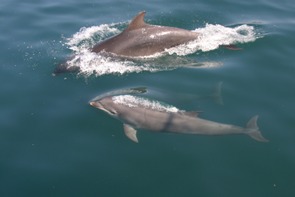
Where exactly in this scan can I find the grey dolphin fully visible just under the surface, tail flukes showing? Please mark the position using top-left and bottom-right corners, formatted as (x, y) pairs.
(90, 95), (268, 142)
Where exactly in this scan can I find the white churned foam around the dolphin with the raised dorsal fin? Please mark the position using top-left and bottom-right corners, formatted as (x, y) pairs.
(66, 23), (259, 77)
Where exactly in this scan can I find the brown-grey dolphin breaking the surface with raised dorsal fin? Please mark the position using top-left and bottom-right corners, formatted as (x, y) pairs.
(54, 11), (199, 74)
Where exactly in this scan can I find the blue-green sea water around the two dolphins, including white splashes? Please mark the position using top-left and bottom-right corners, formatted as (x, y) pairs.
(0, 0), (295, 197)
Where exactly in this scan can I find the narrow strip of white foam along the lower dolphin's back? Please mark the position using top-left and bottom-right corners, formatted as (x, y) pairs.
(112, 95), (179, 113)
